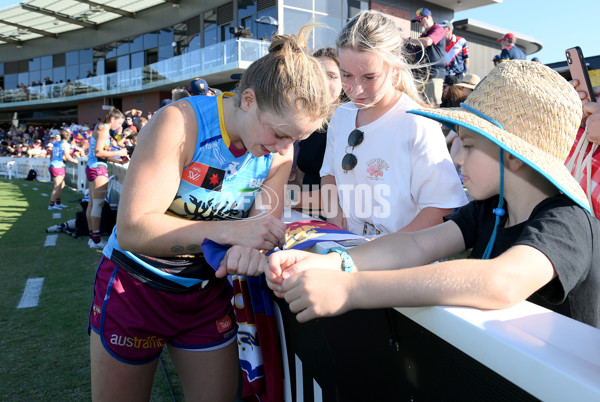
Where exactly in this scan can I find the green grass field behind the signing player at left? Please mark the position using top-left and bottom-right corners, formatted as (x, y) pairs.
(0, 179), (183, 401)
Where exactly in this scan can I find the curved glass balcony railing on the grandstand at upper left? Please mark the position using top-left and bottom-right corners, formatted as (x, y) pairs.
(0, 38), (269, 108)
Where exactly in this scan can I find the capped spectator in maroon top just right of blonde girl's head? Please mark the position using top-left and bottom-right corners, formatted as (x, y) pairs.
(409, 8), (446, 106)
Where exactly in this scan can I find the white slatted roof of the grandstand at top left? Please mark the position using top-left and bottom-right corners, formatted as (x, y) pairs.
(0, 0), (179, 47)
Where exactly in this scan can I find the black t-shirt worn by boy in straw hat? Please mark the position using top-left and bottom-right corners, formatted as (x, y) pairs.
(446, 195), (600, 328)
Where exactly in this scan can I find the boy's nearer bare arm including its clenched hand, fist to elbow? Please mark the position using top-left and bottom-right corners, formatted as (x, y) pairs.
(276, 245), (556, 322)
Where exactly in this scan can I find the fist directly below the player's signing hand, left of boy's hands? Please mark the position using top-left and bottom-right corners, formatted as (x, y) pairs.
(215, 246), (268, 278)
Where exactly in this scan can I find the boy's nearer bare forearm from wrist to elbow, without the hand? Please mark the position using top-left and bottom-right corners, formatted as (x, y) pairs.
(349, 246), (556, 309)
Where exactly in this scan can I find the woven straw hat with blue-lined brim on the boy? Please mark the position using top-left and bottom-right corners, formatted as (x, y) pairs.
(409, 60), (590, 211)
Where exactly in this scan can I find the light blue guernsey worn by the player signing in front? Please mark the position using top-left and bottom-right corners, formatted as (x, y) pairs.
(103, 93), (273, 292)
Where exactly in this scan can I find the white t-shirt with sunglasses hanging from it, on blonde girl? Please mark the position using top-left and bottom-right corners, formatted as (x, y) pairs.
(320, 94), (467, 234)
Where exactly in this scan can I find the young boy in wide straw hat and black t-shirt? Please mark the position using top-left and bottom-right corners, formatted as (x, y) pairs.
(267, 60), (600, 327)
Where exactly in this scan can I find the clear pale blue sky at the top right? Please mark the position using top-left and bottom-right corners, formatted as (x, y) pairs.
(0, 0), (600, 63)
